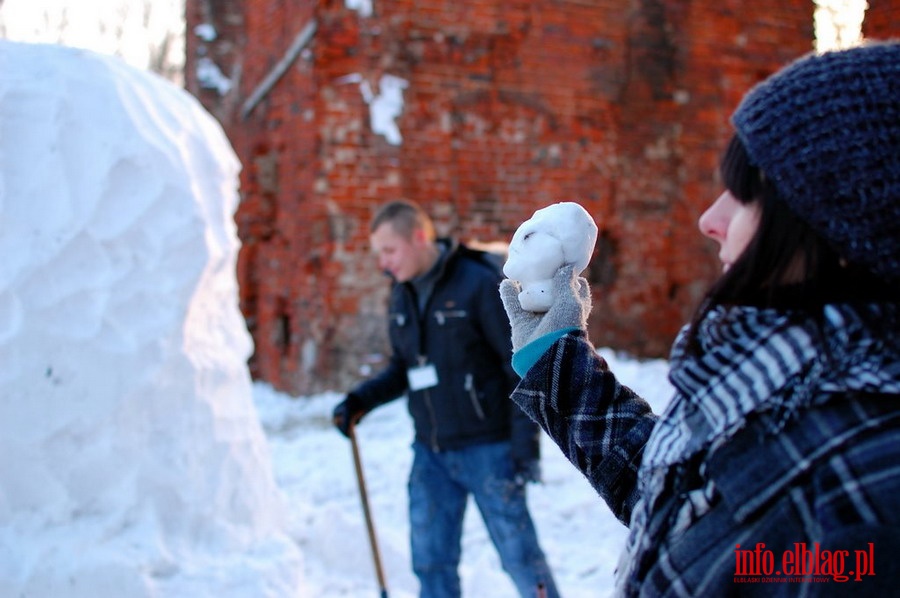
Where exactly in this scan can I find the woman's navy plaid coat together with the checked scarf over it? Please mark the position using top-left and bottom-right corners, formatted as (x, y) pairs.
(512, 305), (900, 596)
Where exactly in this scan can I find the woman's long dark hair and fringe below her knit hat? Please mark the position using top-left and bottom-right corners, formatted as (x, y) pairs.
(690, 134), (897, 348)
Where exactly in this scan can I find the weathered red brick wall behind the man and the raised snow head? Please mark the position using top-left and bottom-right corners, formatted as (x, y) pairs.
(187, 0), (813, 394)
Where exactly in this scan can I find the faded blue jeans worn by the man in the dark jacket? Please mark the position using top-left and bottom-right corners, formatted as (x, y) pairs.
(409, 442), (559, 598)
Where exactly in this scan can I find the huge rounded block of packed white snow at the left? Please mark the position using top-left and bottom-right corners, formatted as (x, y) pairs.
(0, 41), (302, 598)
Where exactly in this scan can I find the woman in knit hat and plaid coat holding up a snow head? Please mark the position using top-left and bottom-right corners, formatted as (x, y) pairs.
(500, 43), (900, 596)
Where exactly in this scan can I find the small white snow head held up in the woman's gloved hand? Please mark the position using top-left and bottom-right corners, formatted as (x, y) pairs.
(503, 201), (597, 313)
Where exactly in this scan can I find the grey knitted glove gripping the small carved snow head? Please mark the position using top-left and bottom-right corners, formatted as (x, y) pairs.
(500, 265), (591, 351)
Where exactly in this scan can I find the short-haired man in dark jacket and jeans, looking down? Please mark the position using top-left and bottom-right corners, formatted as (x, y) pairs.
(334, 201), (558, 598)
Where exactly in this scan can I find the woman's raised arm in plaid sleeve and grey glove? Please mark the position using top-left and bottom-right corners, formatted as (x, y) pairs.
(501, 267), (657, 524)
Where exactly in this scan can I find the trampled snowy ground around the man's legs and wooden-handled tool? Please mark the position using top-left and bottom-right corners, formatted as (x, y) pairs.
(254, 350), (671, 598)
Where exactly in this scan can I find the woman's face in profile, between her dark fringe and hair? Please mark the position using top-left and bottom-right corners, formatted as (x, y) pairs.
(698, 191), (760, 272)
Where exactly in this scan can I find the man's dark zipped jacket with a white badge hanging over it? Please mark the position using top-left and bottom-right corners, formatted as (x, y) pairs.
(350, 240), (539, 462)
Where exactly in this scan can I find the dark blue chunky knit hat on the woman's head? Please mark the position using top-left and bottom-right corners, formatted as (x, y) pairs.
(732, 41), (900, 281)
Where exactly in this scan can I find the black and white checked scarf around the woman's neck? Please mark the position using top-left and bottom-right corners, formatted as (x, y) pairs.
(619, 303), (900, 592)
